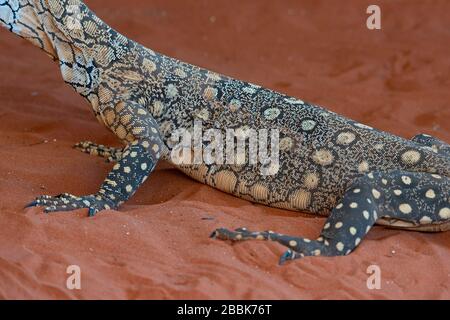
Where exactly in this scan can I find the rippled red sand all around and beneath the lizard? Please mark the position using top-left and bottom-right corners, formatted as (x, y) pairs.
(0, 0), (450, 299)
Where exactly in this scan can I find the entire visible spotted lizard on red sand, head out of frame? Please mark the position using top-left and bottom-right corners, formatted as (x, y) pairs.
(0, 0), (450, 262)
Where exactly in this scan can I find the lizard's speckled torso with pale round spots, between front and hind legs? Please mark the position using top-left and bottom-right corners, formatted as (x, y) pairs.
(100, 35), (450, 218)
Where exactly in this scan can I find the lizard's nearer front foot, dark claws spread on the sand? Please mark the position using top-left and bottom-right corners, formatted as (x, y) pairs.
(25, 193), (116, 217)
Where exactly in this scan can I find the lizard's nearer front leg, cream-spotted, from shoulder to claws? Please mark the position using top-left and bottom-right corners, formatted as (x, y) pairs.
(27, 103), (163, 216)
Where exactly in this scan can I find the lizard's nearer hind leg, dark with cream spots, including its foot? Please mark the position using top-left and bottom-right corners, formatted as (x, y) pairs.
(211, 171), (450, 263)
